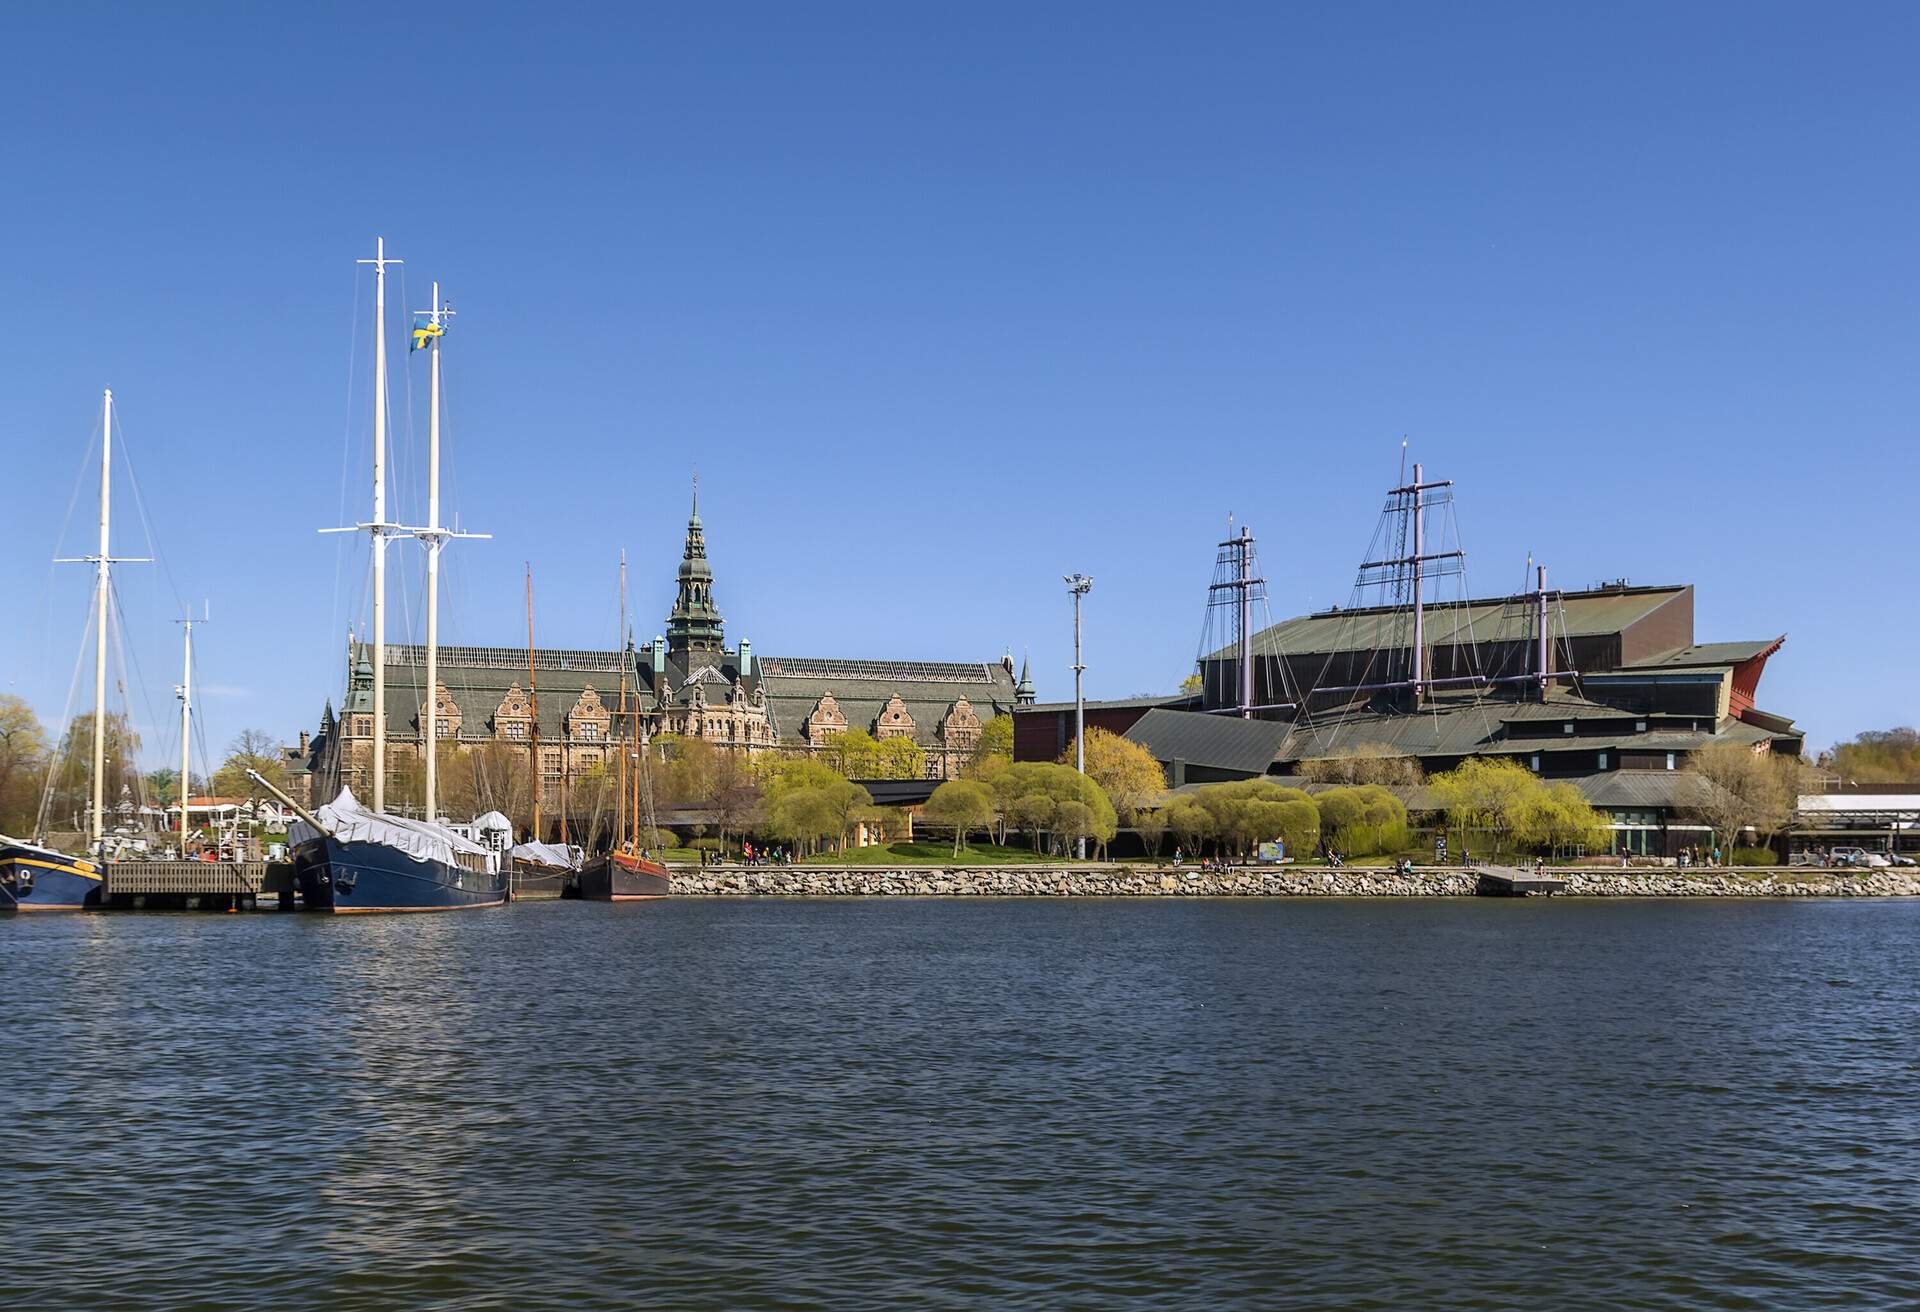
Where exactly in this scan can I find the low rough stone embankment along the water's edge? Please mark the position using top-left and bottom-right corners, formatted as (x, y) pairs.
(674, 864), (1920, 897)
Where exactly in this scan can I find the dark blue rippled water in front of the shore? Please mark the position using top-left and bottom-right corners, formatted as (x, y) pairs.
(0, 899), (1920, 1310)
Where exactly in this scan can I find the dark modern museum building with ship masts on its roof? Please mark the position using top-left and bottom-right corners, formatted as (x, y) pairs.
(1014, 465), (1805, 856)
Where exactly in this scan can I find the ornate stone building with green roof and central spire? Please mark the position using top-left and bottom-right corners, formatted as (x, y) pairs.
(290, 486), (1033, 795)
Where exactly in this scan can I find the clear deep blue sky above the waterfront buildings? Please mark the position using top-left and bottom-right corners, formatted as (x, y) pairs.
(0, 4), (1920, 759)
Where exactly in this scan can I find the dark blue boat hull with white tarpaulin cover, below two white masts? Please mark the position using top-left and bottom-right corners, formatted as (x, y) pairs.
(284, 791), (507, 914)
